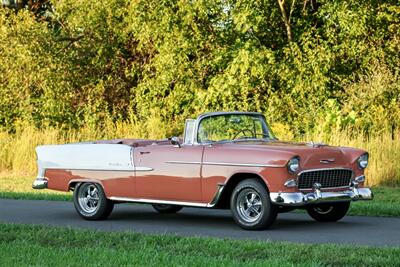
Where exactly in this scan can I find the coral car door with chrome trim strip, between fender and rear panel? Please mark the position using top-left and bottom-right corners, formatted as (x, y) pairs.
(134, 144), (203, 202)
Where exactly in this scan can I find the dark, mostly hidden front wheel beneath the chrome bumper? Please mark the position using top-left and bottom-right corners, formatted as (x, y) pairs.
(307, 202), (350, 222)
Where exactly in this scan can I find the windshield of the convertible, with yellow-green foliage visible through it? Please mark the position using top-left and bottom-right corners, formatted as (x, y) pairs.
(197, 114), (273, 143)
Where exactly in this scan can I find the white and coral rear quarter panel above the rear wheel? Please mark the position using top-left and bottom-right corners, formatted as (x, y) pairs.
(36, 144), (135, 197)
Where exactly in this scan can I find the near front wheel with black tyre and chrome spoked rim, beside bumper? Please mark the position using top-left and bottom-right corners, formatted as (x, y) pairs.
(230, 179), (277, 230)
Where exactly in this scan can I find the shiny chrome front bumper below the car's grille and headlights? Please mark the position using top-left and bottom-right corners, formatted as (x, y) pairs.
(269, 188), (374, 207)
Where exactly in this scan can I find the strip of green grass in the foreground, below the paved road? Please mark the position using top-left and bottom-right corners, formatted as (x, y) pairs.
(0, 224), (400, 266)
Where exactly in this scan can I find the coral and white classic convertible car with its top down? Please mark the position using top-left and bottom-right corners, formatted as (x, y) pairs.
(33, 112), (373, 230)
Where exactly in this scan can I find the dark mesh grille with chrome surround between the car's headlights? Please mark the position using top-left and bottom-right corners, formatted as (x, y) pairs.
(298, 169), (353, 189)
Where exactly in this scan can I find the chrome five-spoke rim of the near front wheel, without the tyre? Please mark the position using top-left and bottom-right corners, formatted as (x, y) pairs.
(236, 189), (263, 223)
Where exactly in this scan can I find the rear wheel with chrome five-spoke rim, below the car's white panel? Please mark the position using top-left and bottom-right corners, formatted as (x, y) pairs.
(74, 183), (114, 220)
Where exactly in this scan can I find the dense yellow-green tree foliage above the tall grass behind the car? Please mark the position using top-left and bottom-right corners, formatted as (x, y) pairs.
(0, 0), (400, 137)
